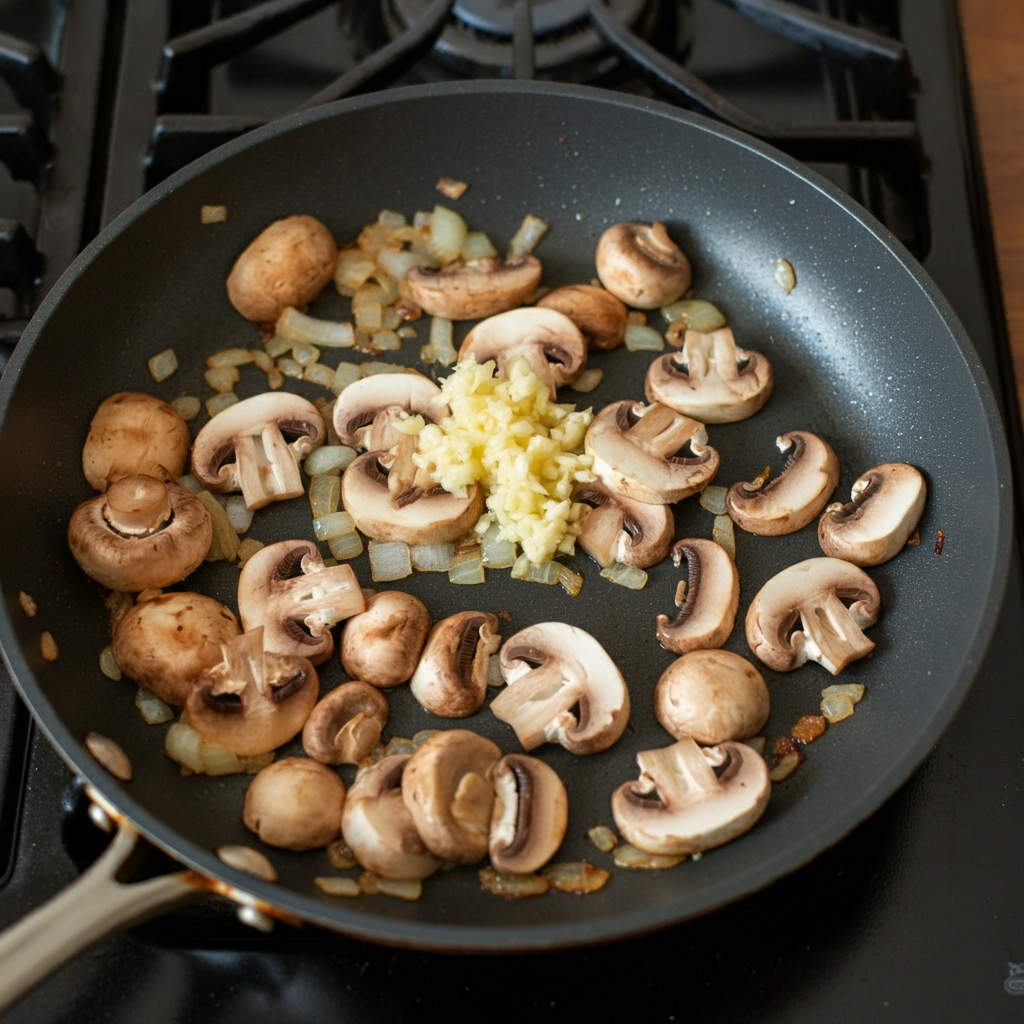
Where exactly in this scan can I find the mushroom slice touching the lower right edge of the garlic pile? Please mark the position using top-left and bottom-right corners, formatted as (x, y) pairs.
(572, 480), (676, 569)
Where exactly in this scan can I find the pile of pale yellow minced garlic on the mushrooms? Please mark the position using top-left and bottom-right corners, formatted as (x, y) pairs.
(409, 357), (595, 564)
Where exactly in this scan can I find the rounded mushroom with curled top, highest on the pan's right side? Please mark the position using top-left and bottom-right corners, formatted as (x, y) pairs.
(594, 220), (691, 309)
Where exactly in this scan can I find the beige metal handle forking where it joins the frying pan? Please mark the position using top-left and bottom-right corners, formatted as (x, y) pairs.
(0, 819), (209, 1011)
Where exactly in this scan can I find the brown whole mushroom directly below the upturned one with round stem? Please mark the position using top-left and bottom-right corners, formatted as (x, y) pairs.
(113, 591), (242, 708)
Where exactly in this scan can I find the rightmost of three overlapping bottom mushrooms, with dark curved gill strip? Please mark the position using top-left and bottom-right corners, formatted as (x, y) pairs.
(488, 754), (569, 874)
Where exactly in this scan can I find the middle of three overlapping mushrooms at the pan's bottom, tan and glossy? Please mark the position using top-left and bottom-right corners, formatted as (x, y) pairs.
(401, 729), (502, 864)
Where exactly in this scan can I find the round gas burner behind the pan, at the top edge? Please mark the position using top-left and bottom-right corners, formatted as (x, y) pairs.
(384, 0), (659, 82)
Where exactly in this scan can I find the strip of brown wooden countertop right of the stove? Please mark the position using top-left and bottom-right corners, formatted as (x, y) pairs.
(958, 0), (1024, 408)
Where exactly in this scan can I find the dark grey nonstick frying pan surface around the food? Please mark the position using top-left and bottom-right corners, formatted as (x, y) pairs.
(0, 82), (1011, 1007)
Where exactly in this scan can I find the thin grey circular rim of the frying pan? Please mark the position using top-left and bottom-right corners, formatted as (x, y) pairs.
(0, 81), (1013, 952)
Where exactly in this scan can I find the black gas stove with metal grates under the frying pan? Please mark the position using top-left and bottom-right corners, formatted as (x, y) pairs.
(0, 0), (1024, 1024)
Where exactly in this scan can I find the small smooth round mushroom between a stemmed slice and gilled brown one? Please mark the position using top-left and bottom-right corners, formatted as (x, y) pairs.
(341, 590), (430, 689)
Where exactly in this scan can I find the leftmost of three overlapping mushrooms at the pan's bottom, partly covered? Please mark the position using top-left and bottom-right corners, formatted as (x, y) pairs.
(341, 754), (441, 880)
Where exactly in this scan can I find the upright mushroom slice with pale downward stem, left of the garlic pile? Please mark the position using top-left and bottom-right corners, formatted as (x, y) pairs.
(193, 391), (327, 510)
